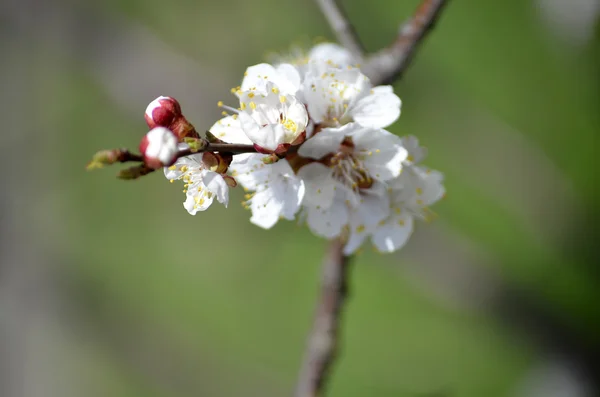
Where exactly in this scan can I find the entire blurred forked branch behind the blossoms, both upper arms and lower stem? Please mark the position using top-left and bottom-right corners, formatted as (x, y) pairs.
(296, 0), (447, 397)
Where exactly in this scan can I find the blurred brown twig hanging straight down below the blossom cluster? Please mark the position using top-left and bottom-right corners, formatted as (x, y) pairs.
(296, 240), (350, 397)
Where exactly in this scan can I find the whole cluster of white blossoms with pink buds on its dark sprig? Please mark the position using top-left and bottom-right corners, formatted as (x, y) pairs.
(91, 43), (444, 255)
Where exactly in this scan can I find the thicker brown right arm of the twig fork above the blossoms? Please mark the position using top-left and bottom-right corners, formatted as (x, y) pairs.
(362, 0), (448, 85)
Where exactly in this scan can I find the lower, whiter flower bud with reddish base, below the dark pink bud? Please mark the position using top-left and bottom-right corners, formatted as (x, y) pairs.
(140, 127), (177, 169)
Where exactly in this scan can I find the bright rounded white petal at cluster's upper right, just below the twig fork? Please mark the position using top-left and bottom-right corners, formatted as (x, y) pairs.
(349, 90), (402, 128)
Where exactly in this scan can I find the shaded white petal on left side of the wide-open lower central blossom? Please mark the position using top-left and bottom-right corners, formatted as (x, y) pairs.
(298, 163), (336, 209)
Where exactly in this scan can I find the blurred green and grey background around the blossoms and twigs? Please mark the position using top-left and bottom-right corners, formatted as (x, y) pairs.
(0, 0), (600, 397)
